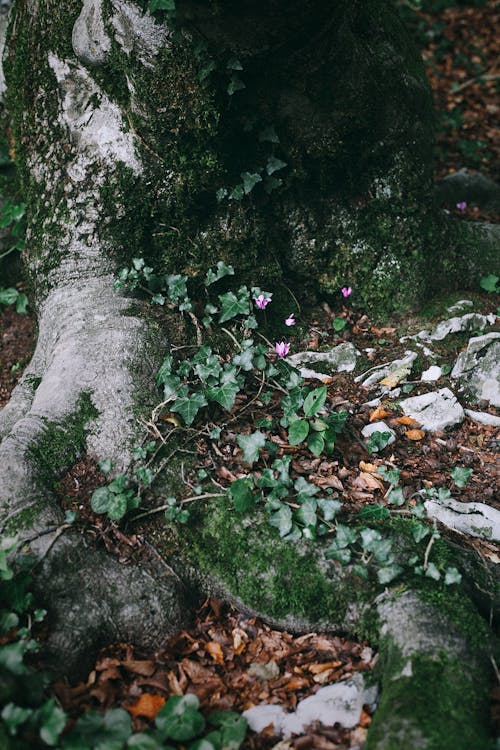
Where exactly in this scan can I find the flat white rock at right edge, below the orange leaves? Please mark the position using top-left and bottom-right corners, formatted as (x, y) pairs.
(425, 498), (500, 542)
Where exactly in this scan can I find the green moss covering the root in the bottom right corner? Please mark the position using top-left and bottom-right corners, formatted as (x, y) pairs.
(366, 652), (493, 750)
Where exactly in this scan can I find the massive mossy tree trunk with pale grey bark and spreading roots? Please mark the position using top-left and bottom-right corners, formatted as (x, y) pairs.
(0, 0), (496, 750)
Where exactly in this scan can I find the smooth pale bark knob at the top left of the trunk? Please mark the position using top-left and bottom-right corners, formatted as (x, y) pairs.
(71, 0), (111, 67)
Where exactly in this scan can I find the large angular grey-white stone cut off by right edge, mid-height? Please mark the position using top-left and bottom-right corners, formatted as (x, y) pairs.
(451, 333), (500, 407)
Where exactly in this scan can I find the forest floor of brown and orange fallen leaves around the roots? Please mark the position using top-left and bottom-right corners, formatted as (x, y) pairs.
(0, 1), (500, 750)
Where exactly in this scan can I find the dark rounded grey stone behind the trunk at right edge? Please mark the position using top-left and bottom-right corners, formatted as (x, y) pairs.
(435, 168), (500, 210)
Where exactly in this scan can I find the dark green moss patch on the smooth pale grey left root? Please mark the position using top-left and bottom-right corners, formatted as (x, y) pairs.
(30, 393), (99, 489)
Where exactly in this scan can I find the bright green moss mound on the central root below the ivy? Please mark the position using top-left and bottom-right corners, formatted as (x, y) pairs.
(176, 499), (376, 626)
